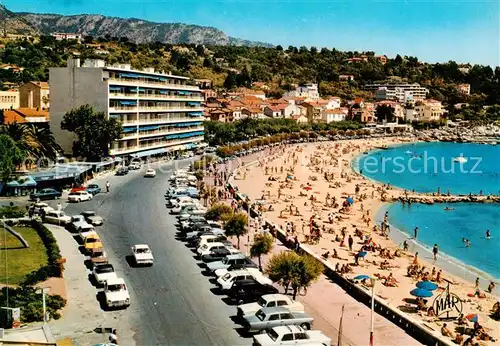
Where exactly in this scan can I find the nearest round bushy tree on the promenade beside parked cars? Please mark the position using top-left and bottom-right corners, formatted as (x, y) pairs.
(265, 251), (323, 299)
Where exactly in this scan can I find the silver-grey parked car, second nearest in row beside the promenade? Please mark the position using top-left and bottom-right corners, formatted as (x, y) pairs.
(243, 307), (314, 331)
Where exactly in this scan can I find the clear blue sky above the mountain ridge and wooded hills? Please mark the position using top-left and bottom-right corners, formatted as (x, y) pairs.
(0, 0), (500, 66)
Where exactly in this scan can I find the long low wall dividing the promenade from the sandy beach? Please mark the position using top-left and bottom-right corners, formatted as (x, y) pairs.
(228, 176), (455, 346)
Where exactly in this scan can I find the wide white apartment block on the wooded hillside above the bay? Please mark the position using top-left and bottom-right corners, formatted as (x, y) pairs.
(365, 83), (429, 103)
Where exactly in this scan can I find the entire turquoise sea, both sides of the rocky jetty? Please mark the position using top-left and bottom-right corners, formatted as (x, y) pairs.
(353, 142), (500, 284)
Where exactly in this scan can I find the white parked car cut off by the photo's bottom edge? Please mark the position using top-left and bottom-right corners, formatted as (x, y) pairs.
(253, 325), (332, 346)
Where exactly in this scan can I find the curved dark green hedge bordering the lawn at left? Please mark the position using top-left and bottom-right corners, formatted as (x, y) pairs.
(18, 220), (62, 285)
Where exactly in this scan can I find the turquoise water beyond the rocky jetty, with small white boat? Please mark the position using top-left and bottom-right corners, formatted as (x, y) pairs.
(353, 142), (500, 195)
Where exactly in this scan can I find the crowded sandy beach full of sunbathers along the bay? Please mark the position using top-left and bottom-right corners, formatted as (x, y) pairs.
(234, 138), (500, 345)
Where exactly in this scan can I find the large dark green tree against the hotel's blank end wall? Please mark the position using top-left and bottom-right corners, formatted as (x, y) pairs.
(61, 105), (122, 161)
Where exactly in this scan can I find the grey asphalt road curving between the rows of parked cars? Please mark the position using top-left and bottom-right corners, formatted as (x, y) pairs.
(65, 162), (251, 345)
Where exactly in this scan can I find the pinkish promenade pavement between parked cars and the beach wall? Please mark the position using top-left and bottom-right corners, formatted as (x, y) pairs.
(234, 230), (421, 346)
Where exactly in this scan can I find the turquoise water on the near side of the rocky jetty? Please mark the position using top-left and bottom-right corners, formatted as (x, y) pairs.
(387, 203), (500, 278)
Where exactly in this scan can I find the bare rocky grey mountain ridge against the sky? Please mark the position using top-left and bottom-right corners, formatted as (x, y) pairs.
(6, 10), (271, 47)
